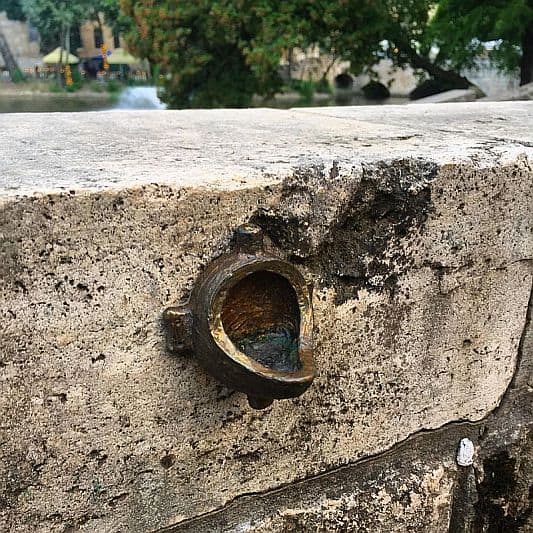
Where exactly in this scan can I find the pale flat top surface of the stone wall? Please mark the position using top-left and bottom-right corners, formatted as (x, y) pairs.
(0, 102), (532, 197)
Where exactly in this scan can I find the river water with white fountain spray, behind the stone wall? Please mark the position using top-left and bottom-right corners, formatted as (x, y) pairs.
(0, 87), (407, 113)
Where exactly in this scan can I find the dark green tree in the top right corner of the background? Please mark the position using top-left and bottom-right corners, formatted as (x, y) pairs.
(428, 0), (533, 84)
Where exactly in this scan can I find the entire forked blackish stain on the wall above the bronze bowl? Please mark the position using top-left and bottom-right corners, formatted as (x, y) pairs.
(253, 159), (438, 304)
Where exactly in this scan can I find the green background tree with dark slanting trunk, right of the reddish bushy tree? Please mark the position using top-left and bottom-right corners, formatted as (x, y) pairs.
(231, 0), (472, 88)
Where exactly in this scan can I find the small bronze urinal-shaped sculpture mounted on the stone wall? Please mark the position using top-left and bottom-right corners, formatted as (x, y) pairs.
(163, 222), (315, 409)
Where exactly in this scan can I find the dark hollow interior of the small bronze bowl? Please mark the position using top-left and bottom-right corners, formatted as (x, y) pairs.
(222, 271), (302, 372)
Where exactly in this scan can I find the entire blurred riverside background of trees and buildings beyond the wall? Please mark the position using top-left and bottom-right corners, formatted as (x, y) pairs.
(0, 0), (533, 113)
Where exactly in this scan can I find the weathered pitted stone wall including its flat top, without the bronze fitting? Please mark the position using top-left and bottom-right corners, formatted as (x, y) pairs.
(0, 102), (533, 533)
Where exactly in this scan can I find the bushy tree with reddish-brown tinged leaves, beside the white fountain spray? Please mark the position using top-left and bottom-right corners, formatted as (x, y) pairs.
(121, 0), (280, 107)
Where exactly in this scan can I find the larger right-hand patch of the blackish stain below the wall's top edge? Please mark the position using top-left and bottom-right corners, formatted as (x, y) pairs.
(320, 160), (436, 303)
